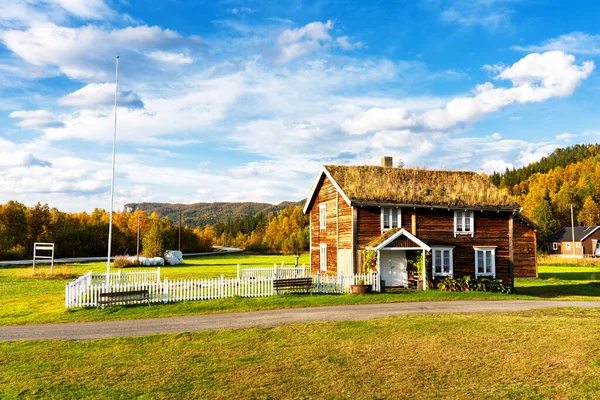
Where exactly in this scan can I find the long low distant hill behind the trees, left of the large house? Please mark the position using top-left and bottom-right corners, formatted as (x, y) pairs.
(125, 200), (304, 227)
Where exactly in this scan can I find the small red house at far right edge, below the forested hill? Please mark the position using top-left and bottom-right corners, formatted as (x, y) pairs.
(548, 226), (600, 257)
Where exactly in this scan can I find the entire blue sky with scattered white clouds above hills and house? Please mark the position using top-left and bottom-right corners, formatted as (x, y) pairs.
(0, 0), (600, 211)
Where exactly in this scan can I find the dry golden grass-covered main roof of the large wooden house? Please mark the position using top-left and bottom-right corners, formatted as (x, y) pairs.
(325, 165), (518, 207)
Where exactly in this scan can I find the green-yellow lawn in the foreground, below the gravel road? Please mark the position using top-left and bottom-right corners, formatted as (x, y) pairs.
(0, 309), (600, 399)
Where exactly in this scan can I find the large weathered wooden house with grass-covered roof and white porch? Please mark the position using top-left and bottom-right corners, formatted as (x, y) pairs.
(304, 157), (537, 287)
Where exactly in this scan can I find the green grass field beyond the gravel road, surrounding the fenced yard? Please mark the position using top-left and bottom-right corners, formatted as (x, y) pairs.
(0, 254), (600, 325)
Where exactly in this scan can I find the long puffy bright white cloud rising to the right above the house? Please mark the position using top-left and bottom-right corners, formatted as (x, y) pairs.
(341, 51), (594, 134)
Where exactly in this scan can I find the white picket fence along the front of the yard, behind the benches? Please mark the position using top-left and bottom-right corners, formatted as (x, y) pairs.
(65, 272), (381, 308)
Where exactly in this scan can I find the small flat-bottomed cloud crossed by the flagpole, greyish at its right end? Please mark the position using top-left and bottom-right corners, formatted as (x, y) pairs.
(58, 83), (144, 108)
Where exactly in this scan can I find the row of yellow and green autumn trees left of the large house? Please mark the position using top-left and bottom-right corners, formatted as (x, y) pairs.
(0, 201), (309, 260)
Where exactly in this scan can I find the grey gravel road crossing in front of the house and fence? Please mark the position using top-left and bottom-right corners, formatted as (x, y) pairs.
(0, 300), (600, 341)
